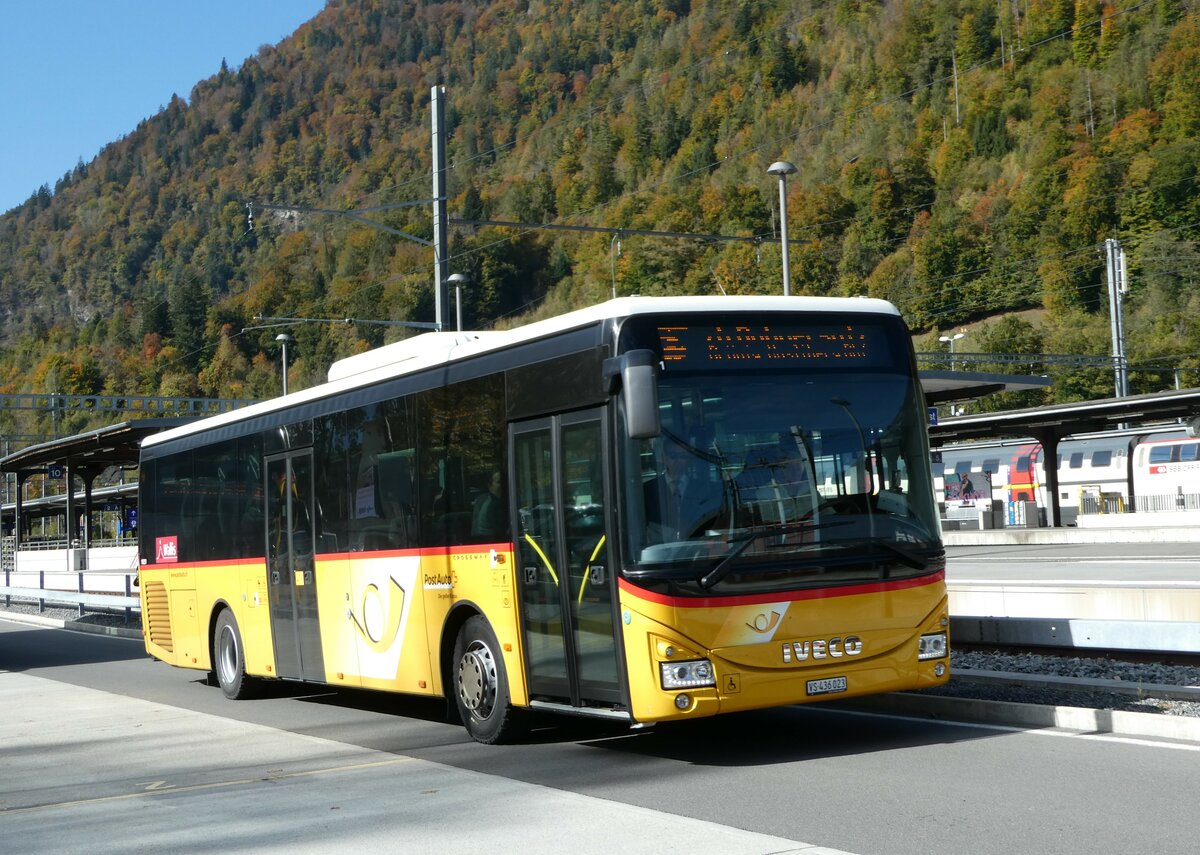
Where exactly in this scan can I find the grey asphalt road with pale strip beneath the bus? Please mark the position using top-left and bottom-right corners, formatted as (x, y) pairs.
(0, 621), (1200, 855)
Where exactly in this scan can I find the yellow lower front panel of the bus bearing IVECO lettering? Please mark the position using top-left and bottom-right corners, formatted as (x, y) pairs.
(620, 581), (949, 722)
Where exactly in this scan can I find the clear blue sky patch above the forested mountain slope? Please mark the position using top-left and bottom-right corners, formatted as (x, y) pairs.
(0, 0), (325, 213)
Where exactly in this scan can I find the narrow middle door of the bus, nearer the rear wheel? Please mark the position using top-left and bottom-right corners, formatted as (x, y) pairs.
(266, 452), (325, 682)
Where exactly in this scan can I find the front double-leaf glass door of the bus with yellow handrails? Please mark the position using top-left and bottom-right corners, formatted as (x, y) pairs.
(509, 411), (625, 708)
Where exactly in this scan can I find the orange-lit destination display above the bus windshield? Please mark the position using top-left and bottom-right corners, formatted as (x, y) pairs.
(659, 323), (889, 370)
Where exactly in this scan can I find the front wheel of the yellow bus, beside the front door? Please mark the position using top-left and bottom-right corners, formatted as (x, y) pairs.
(451, 615), (516, 745)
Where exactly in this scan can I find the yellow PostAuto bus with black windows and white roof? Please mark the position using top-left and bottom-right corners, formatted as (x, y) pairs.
(139, 297), (949, 742)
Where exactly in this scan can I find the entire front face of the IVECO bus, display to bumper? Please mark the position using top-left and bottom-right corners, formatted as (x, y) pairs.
(609, 300), (949, 718)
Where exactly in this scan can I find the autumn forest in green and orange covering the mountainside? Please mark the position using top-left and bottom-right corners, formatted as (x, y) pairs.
(0, 0), (1200, 435)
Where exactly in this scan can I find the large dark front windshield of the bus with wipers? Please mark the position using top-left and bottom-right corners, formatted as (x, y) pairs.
(623, 366), (943, 594)
